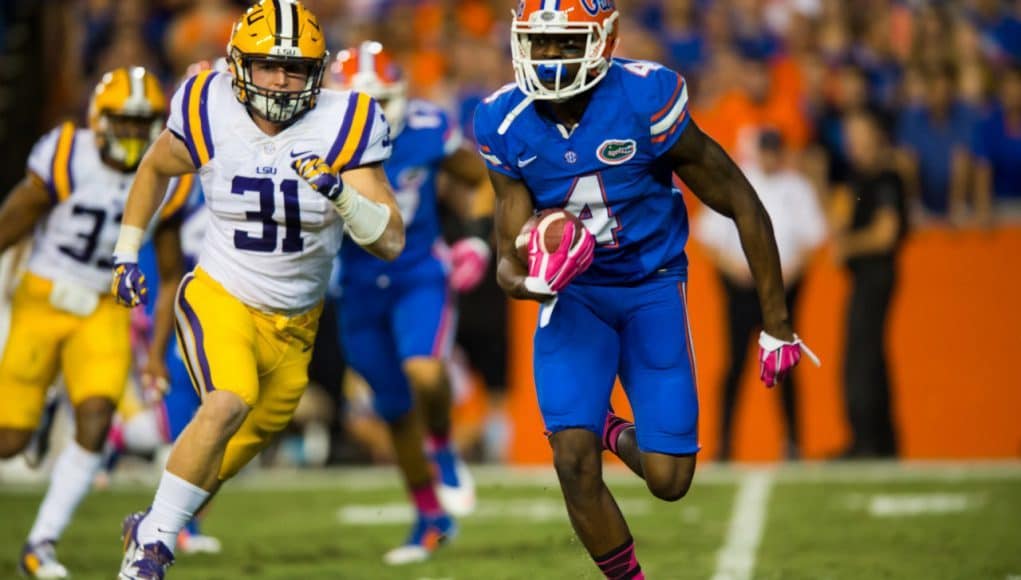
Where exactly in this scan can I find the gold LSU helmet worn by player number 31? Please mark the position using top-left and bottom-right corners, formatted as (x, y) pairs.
(227, 0), (329, 124)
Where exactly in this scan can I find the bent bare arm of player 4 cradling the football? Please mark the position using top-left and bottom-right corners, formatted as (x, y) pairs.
(489, 171), (550, 302)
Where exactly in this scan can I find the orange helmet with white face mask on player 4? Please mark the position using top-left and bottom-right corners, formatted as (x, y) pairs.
(511, 0), (619, 100)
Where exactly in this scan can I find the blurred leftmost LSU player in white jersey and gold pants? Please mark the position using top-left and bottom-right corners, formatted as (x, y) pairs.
(0, 67), (191, 578)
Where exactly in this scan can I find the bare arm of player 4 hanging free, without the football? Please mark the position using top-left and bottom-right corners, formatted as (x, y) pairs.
(666, 120), (794, 341)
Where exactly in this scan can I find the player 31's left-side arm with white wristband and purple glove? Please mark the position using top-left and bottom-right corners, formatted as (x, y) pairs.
(110, 129), (195, 306)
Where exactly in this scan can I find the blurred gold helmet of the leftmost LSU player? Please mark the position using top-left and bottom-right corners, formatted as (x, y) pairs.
(89, 66), (166, 172)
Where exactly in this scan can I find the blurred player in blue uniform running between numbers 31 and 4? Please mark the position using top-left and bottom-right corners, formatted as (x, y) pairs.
(331, 42), (490, 564)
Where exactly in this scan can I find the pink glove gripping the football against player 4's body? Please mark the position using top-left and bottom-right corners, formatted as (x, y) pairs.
(525, 222), (595, 294)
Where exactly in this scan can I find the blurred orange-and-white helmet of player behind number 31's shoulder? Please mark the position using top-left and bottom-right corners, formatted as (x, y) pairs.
(330, 41), (407, 136)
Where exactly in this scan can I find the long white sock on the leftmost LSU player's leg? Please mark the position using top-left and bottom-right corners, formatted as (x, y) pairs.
(29, 440), (103, 543)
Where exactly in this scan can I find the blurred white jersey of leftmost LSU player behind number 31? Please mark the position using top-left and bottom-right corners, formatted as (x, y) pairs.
(28, 123), (193, 293)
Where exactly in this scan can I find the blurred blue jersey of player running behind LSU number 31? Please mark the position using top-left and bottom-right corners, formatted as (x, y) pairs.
(340, 100), (461, 285)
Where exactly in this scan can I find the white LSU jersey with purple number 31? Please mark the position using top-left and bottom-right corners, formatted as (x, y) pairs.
(167, 70), (390, 313)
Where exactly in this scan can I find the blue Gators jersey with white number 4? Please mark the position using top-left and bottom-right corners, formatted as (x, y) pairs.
(475, 59), (689, 285)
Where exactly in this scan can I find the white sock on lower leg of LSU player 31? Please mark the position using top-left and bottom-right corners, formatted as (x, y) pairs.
(138, 471), (209, 551)
